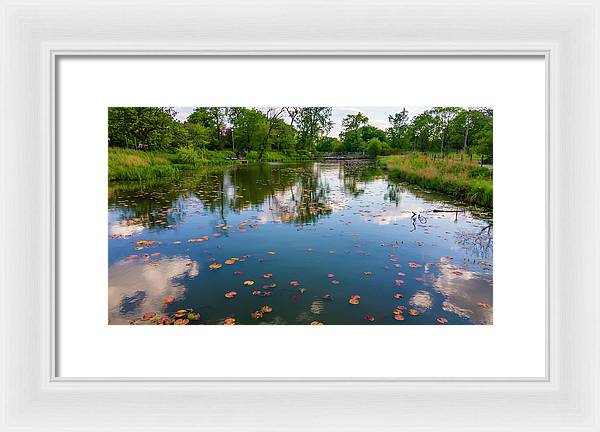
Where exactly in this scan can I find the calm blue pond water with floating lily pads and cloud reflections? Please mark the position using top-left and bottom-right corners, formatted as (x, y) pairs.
(108, 162), (493, 325)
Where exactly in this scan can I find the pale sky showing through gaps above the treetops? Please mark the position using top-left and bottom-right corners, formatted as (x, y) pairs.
(175, 106), (429, 137)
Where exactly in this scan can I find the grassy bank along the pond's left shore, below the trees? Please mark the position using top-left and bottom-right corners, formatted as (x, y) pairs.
(108, 147), (318, 181)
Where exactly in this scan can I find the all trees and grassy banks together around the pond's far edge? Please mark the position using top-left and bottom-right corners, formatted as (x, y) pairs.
(108, 107), (493, 207)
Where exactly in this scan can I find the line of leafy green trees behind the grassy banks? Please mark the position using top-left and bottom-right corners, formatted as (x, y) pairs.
(108, 107), (493, 157)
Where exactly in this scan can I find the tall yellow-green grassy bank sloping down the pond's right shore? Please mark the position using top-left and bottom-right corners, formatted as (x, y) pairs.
(379, 153), (493, 208)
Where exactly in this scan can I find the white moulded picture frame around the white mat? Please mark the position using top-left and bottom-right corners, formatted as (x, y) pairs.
(0, 0), (600, 432)
